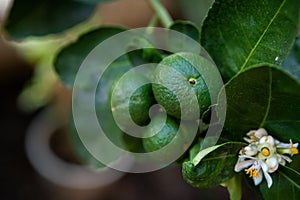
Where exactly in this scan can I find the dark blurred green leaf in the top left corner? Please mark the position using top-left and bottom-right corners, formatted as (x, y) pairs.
(5, 0), (96, 39)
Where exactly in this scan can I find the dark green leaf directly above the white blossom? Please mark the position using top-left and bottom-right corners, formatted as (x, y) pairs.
(224, 65), (300, 142)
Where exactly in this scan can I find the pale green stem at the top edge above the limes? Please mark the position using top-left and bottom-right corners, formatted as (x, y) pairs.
(149, 0), (173, 28)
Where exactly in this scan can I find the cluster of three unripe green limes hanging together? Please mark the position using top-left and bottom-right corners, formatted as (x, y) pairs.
(110, 53), (211, 152)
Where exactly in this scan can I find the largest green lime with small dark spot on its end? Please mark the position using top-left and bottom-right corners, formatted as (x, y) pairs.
(152, 52), (218, 120)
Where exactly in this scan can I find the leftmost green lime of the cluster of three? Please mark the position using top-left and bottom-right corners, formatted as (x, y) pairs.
(110, 73), (155, 128)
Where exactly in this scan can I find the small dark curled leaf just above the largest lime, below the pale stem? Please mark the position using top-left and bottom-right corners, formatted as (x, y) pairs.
(169, 21), (200, 43)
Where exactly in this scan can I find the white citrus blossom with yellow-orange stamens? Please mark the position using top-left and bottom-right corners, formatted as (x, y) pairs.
(234, 128), (299, 188)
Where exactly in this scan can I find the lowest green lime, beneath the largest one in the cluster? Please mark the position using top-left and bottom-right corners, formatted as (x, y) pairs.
(143, 114), (188, 153)
